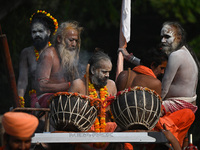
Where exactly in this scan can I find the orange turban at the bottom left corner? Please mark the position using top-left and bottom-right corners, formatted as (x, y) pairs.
(2, 112), (39, 137)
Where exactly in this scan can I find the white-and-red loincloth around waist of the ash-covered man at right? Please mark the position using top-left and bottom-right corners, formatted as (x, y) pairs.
(162, 95), (198, 113)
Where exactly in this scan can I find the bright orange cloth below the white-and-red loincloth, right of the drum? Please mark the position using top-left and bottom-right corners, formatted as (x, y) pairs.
(154, 109), (195, 147)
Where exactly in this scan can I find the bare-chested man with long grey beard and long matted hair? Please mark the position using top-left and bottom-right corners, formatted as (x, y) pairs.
(34, 21), (82, 108)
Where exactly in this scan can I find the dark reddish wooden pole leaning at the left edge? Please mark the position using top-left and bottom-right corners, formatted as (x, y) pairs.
(0, 27), (19, 108)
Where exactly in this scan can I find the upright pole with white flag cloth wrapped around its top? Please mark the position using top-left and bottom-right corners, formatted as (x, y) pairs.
(115, 0), (131, 81)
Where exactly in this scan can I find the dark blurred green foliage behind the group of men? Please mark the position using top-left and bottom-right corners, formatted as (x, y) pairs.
(0, 0), (200, 147)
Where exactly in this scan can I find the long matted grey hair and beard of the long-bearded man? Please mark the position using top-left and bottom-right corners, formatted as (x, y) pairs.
(54, 21), (83, 81)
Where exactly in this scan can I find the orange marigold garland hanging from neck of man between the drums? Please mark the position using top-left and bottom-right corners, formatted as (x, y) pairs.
(89, 81), (108, 147)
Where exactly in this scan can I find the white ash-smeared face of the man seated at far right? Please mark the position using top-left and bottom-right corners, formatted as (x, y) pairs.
(161, 25), (179, 55)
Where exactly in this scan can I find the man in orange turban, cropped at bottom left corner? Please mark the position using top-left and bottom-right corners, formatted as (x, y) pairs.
(0, 112), (39, 150)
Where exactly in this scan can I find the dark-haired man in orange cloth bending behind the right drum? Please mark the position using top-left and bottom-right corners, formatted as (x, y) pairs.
(116, 49), (195, 146)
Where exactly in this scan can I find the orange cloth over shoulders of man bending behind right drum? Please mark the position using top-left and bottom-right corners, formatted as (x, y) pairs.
(133, 65), (157, 78)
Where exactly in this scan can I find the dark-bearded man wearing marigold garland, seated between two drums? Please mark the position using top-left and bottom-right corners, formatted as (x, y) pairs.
(69, 51), (117, 147)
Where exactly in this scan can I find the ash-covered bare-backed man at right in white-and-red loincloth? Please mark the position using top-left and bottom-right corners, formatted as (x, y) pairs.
(161, 22), (198, 113)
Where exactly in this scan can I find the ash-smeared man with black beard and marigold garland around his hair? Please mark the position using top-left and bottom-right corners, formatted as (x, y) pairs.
(17, 10), (58, 107)
